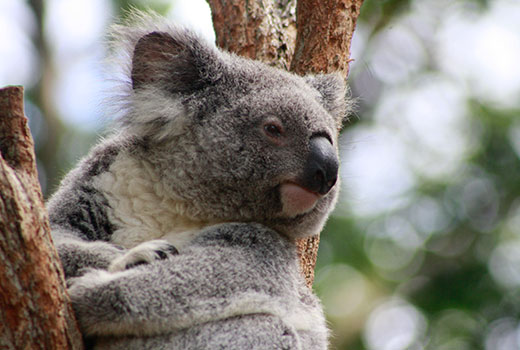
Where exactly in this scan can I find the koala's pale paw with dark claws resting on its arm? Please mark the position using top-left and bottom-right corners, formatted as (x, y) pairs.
(108, 240), (179, 272)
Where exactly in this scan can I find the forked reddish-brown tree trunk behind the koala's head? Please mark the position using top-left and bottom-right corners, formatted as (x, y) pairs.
(207, 0), (363, 287)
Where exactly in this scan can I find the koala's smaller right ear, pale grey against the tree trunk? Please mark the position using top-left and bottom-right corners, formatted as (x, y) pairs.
(305, 73), (351, 129)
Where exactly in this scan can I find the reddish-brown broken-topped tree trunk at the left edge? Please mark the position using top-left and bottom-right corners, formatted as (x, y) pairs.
(0, 87), (83, 349)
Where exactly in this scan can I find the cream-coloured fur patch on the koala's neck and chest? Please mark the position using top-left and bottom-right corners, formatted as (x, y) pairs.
(94, 153), (218, 248)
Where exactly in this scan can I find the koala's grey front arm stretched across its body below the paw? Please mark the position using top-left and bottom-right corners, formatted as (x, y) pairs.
(65, 224), (315, 336)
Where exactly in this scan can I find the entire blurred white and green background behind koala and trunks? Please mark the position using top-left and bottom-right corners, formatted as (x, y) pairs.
(0, 0), (520, 350)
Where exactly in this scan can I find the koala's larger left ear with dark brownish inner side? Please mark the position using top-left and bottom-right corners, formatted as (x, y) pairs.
(131, 31), (216, 93)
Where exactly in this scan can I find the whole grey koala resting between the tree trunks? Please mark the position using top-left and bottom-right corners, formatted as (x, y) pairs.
(47, 12), (349, 349)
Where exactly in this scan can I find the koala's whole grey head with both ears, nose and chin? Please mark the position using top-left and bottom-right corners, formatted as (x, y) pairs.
(112, 12), (347, 237)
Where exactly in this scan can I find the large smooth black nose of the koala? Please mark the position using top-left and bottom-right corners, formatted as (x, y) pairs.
(303, 136), (339, 195)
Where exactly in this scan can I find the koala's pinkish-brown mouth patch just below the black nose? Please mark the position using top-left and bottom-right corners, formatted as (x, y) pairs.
(280, 182), (322, 218)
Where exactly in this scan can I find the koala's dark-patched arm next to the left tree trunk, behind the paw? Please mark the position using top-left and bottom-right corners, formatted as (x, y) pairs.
(47, 142), (125, 278)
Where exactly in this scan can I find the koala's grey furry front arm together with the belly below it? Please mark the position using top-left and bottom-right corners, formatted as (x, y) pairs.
(70, 224), (327, 349)
